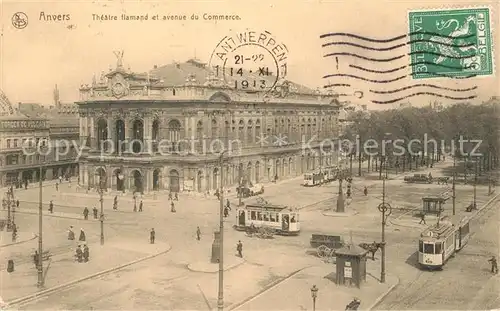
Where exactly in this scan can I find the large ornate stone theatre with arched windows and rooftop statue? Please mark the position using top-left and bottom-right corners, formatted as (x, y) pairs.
(77, 59), (339, 192)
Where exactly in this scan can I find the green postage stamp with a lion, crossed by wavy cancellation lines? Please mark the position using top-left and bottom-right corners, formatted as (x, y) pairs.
(408, 8), (493, 79)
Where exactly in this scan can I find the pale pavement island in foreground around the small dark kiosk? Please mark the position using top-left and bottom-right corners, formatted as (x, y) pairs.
(229, 264), (399, 310)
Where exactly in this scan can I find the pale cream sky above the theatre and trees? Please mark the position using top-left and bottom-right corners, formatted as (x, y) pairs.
(0, 0), (500, 109)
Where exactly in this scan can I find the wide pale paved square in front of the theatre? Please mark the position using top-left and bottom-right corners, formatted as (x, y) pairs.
(0, 163), (498, 310)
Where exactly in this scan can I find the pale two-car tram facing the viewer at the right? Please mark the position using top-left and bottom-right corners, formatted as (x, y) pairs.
(418, 217), (470, 270)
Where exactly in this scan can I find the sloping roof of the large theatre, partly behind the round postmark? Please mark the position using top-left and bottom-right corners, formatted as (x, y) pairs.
(146, 59), (314, 93)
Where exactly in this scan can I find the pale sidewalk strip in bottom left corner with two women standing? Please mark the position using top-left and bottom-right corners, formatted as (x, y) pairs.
(0, 239), (170, 303)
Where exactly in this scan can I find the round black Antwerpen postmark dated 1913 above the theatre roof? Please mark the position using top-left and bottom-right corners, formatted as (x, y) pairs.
(209, 29), (288, 92)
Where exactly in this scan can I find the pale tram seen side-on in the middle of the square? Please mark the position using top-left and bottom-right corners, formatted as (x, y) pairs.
(233, 202), (300, 235)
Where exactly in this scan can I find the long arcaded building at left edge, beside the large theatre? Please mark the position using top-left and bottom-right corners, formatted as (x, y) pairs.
(0, 88), (79, 187)
